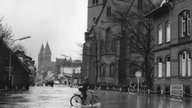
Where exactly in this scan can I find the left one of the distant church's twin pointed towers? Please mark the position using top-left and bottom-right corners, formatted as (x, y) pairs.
(38, 44), (44, 70)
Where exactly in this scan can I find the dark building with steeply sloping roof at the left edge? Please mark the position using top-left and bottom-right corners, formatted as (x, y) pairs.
(0, 38), (30, 90)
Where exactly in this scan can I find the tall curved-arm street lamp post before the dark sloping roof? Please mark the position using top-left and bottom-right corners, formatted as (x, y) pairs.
(8, 36), (31, 88)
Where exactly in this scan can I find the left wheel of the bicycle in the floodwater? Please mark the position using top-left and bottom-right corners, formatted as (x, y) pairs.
(70, 95), (82, 106)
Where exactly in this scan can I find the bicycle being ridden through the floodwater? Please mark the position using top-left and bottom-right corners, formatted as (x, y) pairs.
(70, 91), (99, 106)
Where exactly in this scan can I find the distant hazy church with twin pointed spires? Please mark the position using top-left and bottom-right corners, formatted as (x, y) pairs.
(37, 42), (55, 81)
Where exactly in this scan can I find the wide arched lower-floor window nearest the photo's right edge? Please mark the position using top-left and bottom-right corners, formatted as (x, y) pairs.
(179, 51), (191, 77)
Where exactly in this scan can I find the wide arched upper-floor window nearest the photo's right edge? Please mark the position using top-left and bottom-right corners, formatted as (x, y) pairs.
(179, 10), (190, 37)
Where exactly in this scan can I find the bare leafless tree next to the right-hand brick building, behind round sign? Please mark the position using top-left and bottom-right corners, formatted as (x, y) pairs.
(127, 13), (154, 88)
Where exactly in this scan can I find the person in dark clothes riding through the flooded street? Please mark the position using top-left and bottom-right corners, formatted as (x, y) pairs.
(79, 78), (89, 105)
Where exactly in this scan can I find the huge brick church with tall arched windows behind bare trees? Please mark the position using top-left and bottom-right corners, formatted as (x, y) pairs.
(82, 0), (152, 84)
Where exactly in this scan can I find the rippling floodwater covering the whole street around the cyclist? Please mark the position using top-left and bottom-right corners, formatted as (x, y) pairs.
(0, 86), (192, 108)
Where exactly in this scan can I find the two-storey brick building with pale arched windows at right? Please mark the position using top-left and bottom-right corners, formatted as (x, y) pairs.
(148, 0), (192, 93)
